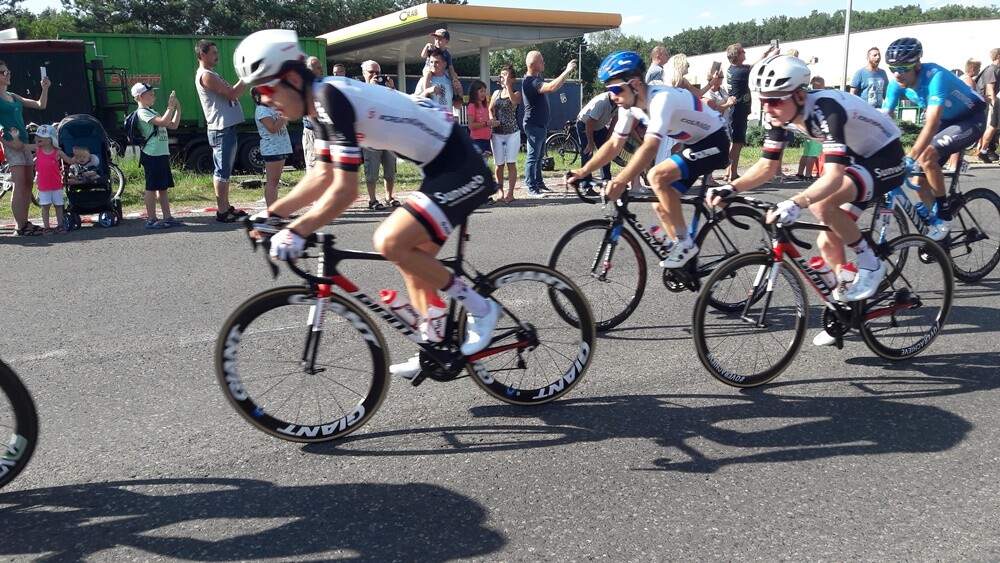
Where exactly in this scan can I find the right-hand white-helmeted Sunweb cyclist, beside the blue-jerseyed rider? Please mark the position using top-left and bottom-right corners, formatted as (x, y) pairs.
(705, 55), (906, 344)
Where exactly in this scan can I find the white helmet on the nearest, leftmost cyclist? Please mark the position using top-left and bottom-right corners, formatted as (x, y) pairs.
(233, 29), (306, 86)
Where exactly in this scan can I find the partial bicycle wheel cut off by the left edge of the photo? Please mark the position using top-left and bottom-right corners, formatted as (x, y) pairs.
(0, 361), (38, 487)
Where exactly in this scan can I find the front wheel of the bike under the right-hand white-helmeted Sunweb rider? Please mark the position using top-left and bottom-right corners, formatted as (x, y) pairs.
(692, 252), (807, 387)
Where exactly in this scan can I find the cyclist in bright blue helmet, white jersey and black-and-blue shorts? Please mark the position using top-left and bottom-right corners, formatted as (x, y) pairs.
(567, 51), (729, 268)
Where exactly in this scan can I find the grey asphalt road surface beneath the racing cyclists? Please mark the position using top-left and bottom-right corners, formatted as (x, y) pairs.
(0, 173), (1000, 561)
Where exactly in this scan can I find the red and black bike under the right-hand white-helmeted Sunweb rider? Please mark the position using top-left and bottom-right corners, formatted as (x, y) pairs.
(692, 195), (955, 387)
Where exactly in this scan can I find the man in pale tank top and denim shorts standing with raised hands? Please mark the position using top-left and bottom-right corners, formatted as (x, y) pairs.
(194, 39), (246, 223)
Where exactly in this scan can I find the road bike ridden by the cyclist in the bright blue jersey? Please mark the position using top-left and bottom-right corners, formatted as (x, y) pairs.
(862, 152), (1000, 282)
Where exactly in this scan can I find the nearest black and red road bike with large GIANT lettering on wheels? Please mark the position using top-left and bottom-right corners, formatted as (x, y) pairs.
(215, 220), (596, 442)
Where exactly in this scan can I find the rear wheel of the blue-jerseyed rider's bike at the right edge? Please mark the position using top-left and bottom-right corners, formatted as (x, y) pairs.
(947, 188), (1000, 282)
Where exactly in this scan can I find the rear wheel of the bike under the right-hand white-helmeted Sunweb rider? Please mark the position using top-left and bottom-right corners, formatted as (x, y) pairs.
(861, 235), (955, 360)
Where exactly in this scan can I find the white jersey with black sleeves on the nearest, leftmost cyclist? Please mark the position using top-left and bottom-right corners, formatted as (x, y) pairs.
(309, 76), (455, 171)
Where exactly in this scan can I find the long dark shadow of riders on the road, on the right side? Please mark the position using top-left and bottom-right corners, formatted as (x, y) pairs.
(303, 354), (1000, 473)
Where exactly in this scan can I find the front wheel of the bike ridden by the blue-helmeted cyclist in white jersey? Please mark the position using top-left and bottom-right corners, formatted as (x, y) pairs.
(549, 219), (647, 332)
